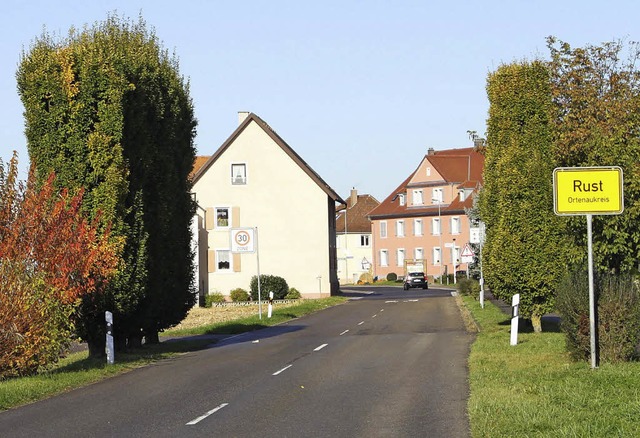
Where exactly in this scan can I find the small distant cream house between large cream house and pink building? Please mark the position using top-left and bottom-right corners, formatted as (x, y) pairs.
(336, 188), (380, 284)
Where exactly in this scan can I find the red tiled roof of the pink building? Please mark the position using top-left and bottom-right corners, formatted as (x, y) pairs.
(369, 148), (484, 219)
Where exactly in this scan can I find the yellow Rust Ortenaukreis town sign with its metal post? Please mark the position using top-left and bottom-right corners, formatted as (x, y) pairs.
(553, 166), (624, 368)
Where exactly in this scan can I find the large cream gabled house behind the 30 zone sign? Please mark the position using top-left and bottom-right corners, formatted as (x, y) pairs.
(192, 112), (344, 298)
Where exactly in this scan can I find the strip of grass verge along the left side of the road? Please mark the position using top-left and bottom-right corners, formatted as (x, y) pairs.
(0, 297), (345, 411)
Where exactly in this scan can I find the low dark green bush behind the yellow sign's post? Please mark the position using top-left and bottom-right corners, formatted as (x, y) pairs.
(557, 271), (640, 362)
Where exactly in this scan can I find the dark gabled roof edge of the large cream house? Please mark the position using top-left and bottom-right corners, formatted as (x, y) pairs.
(193, 113), (346, 204)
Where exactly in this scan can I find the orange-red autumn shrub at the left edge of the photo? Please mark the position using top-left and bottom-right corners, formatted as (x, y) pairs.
(0, 155), (119, 378)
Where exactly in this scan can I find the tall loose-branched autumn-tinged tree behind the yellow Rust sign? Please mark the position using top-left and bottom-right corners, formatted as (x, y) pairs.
(547, 37), (640, 273)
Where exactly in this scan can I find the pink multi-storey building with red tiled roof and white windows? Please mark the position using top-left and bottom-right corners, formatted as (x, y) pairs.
(369, 148), (484, 278)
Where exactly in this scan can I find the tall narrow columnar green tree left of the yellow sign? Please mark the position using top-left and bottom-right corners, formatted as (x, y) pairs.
(478, 61), (567, 330)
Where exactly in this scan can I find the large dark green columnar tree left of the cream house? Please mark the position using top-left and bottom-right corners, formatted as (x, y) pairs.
(17, 16), (196, 354)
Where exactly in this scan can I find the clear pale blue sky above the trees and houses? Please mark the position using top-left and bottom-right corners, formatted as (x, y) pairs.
(0, 0), (640, 201)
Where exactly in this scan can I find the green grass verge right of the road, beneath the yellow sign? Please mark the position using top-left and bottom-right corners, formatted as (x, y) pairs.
(464, 297), (640, 437)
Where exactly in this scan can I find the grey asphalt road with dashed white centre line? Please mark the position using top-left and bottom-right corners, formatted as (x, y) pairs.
(0, 288), (473, 438)
